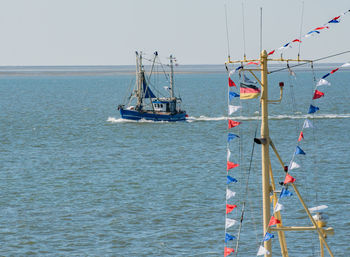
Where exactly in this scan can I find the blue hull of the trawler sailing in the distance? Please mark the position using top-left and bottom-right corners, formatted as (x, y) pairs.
(119, 109), (186, 121)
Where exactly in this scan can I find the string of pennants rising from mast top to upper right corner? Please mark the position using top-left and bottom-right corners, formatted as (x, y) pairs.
(268, 10), (350, 55)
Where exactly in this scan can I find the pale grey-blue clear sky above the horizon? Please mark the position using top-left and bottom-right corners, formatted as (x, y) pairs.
(0, 0), (350, 66)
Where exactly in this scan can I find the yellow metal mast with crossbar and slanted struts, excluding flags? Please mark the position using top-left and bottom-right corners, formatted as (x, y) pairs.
(225, 50), (334, 257)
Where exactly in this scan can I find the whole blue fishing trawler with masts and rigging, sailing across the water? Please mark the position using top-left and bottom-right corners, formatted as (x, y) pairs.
(118, 52), (187, 122)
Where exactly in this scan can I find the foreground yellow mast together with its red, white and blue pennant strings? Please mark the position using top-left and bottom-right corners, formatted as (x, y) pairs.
(224, 10), (350, 257)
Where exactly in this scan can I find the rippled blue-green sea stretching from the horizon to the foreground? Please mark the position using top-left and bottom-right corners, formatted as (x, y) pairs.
(0, 63), (350, 254)
